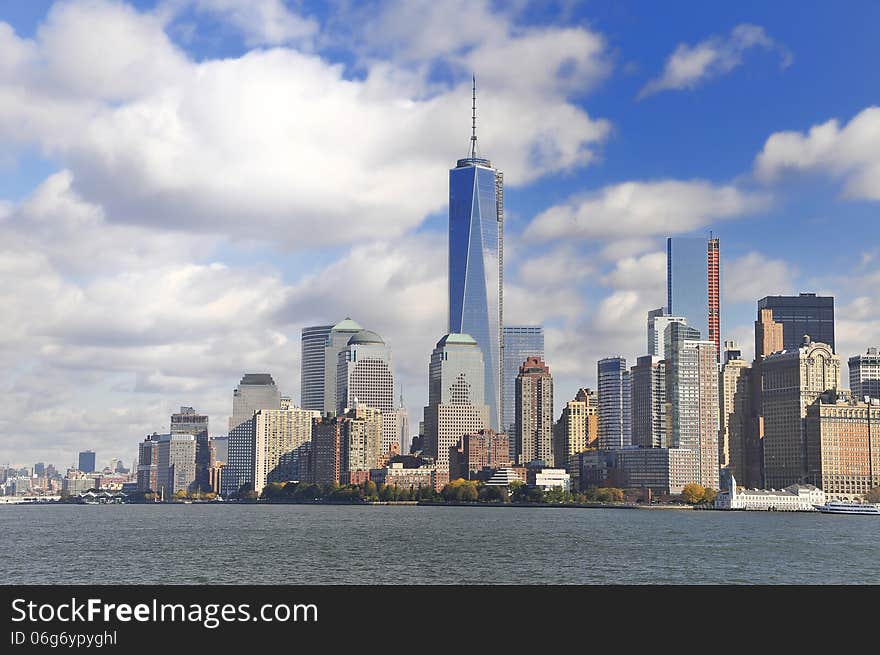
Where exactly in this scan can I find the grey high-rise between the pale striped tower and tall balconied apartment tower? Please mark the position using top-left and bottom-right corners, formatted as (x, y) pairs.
(630, 355), (667, 448)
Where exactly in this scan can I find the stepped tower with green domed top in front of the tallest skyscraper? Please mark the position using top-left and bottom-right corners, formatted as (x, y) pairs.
(423, 334), (489, 488)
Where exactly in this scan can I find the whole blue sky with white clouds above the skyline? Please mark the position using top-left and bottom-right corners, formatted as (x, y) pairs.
(0, 0), (880, 466)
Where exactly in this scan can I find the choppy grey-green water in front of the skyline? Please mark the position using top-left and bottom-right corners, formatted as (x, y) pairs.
(0, 504), (880, 584)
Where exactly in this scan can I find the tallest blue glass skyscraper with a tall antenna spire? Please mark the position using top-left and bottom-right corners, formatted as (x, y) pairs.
(449, 82), (504, 430)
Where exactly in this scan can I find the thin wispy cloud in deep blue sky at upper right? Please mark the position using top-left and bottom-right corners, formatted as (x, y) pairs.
(638, 23), (792, 99)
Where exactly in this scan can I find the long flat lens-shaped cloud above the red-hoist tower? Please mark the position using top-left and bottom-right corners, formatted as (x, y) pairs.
(526, 180), (769, 239)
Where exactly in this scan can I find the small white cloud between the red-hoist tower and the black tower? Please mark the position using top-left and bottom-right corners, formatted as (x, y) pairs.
(721, 251), (797, 303)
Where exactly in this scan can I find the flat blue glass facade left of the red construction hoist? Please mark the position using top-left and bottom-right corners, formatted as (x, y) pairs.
(666, 237), (709, 339)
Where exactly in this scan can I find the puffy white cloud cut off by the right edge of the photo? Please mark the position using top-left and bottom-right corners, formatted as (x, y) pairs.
(755, 107), (880, 200)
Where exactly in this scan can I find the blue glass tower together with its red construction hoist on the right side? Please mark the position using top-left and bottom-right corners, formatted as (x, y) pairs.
(666, 237), (721, 353)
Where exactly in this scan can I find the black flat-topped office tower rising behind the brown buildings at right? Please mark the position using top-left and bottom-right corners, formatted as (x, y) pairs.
(758, 293), (834, 352)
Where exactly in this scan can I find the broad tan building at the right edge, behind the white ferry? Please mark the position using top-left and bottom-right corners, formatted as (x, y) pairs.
(805, 391), (880, 501)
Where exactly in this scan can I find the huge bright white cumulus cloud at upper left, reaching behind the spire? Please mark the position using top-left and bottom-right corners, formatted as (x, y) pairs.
(0, 0), (609, 249)
